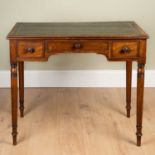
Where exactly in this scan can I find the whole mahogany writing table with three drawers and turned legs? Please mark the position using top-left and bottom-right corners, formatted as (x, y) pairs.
(7, 22), (148, 146)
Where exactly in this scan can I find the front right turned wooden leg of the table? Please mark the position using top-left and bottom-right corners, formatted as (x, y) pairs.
(136, 63), (145, 146)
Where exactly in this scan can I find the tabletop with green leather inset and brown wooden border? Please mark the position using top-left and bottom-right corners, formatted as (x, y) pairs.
(7, 21), (148, 39)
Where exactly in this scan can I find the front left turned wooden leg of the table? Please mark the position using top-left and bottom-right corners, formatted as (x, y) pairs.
(11, 63), (18, 145)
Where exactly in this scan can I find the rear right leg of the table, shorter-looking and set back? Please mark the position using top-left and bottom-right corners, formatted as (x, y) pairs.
(126, 61), (132, 117)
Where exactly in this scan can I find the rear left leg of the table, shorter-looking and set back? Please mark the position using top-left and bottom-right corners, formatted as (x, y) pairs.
(18, 62), (24, 117)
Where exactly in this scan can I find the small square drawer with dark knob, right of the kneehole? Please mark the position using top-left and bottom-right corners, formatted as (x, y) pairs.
(111, 41), (139, 58)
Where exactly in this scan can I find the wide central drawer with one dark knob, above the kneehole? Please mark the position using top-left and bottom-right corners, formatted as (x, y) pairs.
(47, 40), (109, 53)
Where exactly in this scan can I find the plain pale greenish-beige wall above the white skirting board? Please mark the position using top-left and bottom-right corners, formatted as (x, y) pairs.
(0, 0), (155, 70)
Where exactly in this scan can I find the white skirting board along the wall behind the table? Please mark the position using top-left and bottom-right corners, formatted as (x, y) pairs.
(0, 70), (155, 88)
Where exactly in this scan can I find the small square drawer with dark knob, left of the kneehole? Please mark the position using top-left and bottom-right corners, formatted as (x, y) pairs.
(17, 41), (44, 59)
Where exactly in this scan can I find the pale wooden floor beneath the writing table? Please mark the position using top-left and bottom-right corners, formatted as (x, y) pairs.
(0, 88), (155, 155)
